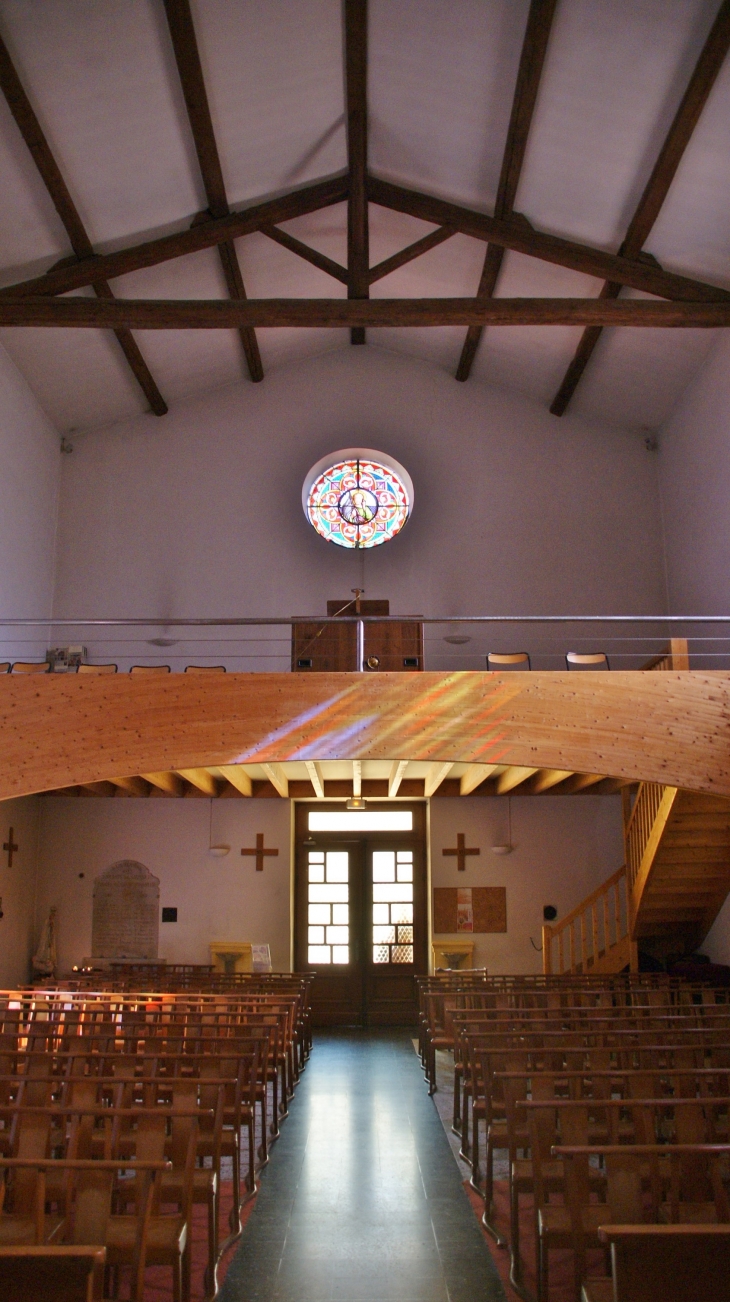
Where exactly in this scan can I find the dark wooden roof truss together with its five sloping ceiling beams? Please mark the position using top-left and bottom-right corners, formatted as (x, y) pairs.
(0, 0), (730, 406)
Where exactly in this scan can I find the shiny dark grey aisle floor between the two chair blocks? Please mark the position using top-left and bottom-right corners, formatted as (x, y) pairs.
(220, 1031), (505, 1302)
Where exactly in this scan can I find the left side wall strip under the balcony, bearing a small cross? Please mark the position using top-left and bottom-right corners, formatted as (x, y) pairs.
(0, 796), (40, 988)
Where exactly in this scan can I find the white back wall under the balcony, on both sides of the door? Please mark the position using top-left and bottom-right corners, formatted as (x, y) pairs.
(31, 796), (622, 973)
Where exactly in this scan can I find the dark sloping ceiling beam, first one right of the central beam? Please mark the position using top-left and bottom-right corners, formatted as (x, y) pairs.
(457, 0), (557, 380)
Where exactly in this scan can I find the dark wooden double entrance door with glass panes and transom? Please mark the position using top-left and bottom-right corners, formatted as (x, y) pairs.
(294, 802), (428, 1026)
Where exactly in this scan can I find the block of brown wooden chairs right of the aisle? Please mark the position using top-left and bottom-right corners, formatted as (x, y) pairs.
(420, 974), (730, 1302)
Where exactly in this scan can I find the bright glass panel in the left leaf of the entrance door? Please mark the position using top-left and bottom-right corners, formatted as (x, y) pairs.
(307, 850), (350, 965)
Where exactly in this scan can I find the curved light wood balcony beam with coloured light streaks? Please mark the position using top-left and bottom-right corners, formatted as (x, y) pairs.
(0, 671), (730, 799)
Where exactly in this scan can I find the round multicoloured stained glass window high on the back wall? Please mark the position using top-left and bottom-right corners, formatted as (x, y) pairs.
(302, 448), (414, 547)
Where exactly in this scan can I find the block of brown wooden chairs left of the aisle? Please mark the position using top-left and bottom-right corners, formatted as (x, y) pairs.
(0, 978), (308, 1302)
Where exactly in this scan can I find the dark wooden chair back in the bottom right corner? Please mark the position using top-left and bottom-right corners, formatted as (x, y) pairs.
(583, 1225), (730, 1302)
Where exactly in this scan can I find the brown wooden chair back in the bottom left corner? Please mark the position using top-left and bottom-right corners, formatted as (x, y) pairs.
(0, 1243), (107, 1302)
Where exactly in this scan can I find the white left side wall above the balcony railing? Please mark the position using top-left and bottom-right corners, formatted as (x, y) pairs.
(0, 345), (61, 660)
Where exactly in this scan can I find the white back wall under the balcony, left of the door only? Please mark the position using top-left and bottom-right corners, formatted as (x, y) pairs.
(36, 797), (290, 971)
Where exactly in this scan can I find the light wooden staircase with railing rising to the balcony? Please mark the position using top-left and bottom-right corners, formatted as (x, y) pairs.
(543, 783), (730, 973)
